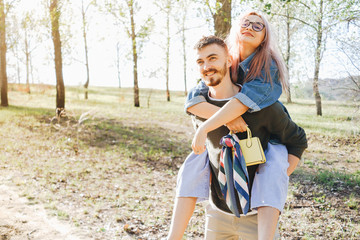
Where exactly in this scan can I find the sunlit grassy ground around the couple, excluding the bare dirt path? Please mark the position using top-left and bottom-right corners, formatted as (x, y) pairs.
(0, 85), (360, 239)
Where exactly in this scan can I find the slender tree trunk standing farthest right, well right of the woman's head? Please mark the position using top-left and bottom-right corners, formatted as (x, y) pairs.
(313, 0), (323, 116)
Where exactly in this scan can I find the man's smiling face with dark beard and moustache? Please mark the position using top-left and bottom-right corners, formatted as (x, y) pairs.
(196, 44), (229, 87)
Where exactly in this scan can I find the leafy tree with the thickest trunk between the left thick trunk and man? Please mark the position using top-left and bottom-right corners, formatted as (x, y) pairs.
(105, 0), (153, 107)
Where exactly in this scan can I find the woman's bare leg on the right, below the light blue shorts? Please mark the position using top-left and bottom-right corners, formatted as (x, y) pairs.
(258, 207), (280, 240)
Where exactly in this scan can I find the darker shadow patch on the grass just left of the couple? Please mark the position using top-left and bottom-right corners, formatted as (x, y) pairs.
(79, 119), (191, 170)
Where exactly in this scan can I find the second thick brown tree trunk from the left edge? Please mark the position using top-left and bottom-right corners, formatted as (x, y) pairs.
(50, 0), (65, 110)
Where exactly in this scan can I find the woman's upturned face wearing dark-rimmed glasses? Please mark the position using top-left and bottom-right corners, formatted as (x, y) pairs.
(240, 15), (266, 48)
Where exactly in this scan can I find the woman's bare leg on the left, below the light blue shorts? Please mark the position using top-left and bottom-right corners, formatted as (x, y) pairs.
(167, 197), (197, 240)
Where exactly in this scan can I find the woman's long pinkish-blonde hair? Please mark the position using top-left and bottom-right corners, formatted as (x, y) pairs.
(226, 12), (289, 92)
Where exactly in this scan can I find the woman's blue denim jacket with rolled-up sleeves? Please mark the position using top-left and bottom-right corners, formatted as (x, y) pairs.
(185, 53), (282, 112)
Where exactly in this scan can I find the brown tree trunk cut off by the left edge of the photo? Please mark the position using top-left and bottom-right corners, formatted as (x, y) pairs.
(0, 0), (9, 107)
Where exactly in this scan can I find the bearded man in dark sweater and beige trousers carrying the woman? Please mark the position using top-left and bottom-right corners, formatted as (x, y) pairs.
(183, 36), (307, 239)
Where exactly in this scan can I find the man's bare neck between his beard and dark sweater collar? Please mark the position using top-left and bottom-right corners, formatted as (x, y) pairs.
(209, 73), (239, 99)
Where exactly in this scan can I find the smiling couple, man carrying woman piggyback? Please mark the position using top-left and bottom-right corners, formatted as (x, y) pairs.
(168, 12), (307, 240)
